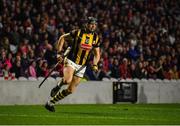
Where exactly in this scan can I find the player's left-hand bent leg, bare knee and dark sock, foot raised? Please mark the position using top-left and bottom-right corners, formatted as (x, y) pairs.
(50, 66), (74, 97)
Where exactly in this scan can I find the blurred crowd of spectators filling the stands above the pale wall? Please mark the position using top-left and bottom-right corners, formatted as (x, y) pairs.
(0, 0), (180, 80)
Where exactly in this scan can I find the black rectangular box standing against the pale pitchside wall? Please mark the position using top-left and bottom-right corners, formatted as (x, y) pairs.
(113, 81), (137, 104)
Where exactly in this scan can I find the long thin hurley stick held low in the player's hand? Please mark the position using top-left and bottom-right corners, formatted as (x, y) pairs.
(39, 47), (71, 88)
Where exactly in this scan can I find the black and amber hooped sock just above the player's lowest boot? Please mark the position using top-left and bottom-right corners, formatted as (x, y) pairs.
(50, 89), (71, 103)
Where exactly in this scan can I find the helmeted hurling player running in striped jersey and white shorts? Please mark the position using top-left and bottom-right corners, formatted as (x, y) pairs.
(45, 17), (100, 112)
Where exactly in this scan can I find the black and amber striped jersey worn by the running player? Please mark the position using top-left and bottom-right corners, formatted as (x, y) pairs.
(67, 29), (100, 65)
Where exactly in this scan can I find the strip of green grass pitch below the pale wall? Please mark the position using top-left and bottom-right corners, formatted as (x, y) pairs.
(0, 104), (180, 125)
